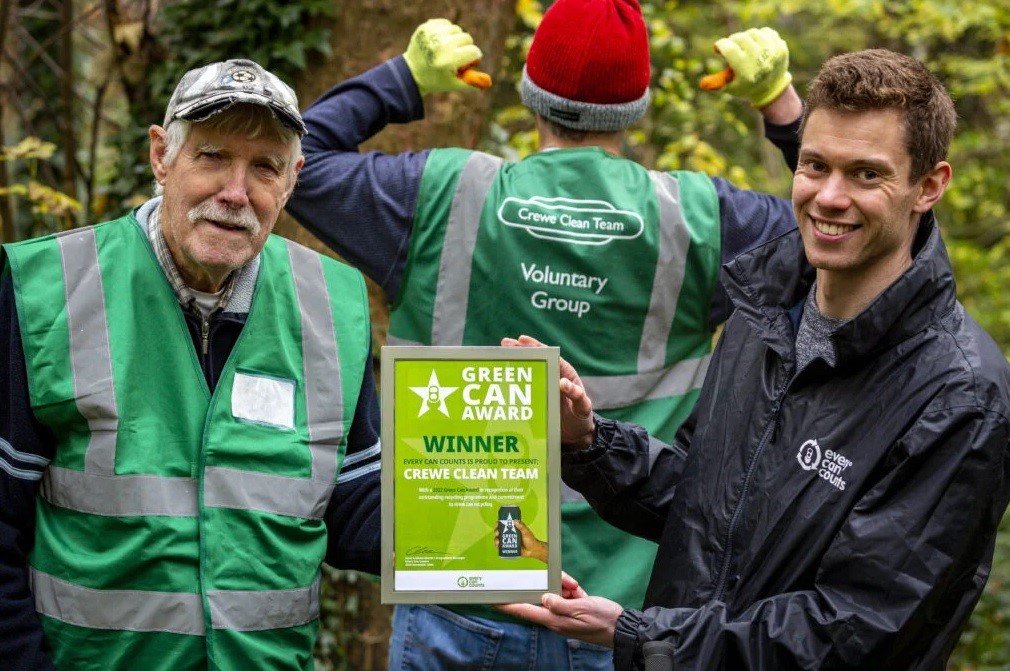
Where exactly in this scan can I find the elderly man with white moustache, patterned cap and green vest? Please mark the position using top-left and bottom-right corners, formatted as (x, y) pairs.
(0, 60), (379, 671)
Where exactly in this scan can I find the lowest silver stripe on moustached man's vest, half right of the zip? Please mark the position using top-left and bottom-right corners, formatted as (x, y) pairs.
(207, 578), (319, 632)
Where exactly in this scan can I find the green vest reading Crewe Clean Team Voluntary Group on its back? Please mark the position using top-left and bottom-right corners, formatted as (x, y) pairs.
(389, 148), (721, 607)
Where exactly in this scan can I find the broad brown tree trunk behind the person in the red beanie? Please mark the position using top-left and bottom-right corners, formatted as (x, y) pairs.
(275, 0), (516, 671)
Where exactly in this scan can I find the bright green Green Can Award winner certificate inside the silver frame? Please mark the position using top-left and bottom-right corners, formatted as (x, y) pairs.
(394, 360), (549, 590)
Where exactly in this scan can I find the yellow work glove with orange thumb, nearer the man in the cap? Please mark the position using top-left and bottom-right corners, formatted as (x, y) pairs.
(403, 18), (491, 96)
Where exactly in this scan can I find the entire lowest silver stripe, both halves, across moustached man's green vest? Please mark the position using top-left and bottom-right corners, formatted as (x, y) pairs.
(31, 569), (319, 636)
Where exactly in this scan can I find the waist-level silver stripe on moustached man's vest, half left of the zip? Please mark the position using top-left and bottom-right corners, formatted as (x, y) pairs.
(41, 466), (197, 517)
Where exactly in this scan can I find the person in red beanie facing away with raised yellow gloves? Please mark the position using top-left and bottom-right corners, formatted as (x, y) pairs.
(288, 0), (802, 671)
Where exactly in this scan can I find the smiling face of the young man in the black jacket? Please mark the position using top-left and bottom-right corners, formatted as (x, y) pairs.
(793, 108), (950, 318)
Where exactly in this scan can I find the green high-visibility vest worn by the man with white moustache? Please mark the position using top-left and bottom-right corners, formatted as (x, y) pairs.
(4, 216), (371, 671)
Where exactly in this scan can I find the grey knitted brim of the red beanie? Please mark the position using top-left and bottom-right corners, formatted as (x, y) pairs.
(519, 67), (649, 132)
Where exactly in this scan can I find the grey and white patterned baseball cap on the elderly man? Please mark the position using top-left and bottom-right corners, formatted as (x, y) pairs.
(164, 59), (305, 135)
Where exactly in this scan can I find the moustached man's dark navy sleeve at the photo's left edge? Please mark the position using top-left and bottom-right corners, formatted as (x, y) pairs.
(0, 272), (56, 671)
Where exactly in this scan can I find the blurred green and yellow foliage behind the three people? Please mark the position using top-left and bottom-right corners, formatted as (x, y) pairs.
(7, 0), (1010, 671)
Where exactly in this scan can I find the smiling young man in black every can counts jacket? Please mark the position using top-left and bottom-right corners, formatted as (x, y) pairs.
(505, 50), (1010, 671)
